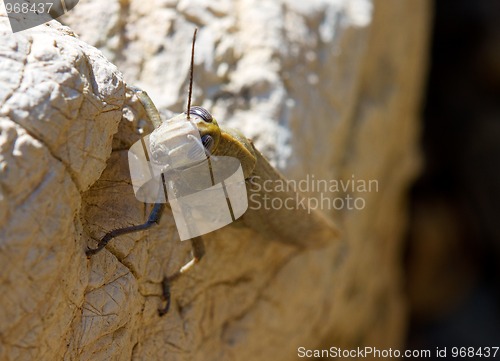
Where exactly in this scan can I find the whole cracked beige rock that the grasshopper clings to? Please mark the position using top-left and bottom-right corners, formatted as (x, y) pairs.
(0, 0), (429, 360)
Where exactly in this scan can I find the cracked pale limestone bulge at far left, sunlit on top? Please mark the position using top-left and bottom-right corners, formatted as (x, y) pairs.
(0, 16), (125, 360)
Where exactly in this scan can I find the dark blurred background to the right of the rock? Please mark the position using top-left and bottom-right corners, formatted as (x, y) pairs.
(406, 0), (500, 357)
